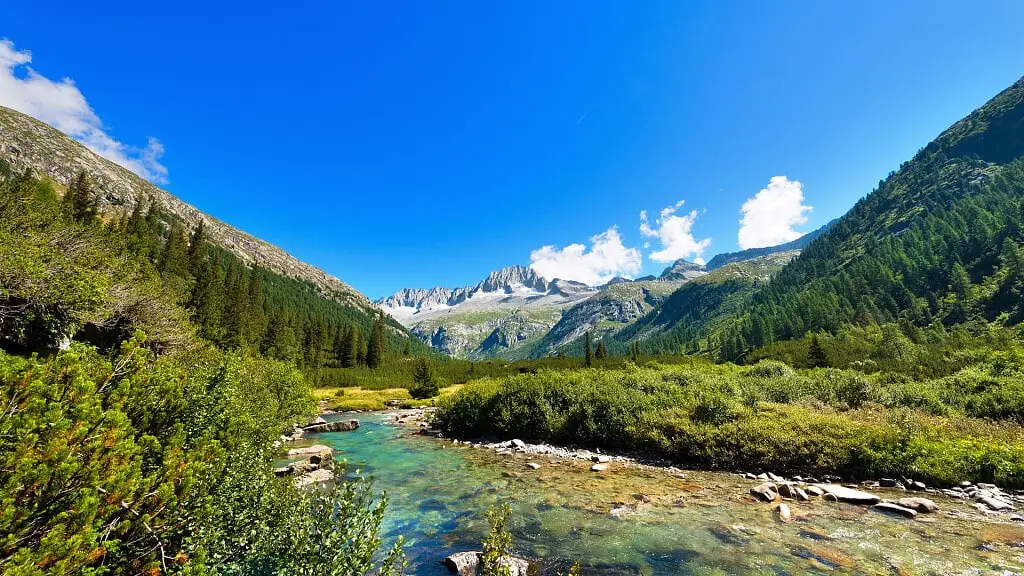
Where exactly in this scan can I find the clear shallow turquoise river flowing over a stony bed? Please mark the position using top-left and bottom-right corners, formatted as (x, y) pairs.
(313, 414), (1024, 576)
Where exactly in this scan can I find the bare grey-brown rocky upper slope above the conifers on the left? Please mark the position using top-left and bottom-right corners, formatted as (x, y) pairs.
(0, 102), (373, 311)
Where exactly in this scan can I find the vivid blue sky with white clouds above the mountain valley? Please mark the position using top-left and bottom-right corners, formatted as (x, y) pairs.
(0, 1), (1024, 297)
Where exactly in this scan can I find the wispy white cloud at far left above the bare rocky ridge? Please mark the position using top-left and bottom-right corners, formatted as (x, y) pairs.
(0, 39), (167, 183)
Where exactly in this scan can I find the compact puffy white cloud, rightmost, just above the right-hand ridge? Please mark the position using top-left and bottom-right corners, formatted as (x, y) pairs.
(739, 176), (811, 250)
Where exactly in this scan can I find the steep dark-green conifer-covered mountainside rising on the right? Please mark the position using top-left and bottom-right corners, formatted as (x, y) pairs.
(655, 73), (1024, 360)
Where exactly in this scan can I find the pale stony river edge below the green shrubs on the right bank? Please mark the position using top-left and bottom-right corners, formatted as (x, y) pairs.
(385, 408), (1024, 524)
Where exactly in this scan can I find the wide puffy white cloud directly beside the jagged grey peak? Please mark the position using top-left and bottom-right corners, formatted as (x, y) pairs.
(529, 227), (643, 286)
